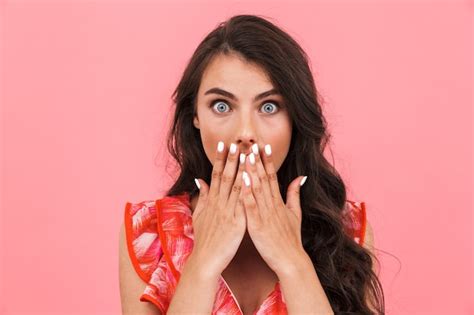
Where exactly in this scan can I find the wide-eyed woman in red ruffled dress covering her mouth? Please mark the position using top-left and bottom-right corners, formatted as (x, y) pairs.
(120, 15), (385, 315)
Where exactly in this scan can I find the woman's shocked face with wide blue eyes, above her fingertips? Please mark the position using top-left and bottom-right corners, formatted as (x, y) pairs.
(194, 55), (292, 170)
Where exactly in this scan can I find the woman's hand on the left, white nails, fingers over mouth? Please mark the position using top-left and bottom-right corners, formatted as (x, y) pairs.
(191, 141), (247, 276)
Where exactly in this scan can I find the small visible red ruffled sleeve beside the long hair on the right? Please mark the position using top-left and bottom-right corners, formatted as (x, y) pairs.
(342, 200), (367, 246)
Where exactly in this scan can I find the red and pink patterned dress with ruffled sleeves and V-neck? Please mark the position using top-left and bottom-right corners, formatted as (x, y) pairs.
(124, 192), (366, 315)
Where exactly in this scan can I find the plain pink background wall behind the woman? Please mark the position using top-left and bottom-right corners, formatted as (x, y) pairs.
(0, 0), (474, 315)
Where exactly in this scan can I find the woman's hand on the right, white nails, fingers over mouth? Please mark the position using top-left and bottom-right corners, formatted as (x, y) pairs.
(242, 144), (308, 275)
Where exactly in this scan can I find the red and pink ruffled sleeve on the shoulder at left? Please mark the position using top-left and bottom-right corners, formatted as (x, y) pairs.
(124, 201), (170, 314)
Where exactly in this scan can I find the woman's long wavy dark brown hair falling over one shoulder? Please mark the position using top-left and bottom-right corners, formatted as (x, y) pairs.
(161, 15), (385, 314)
